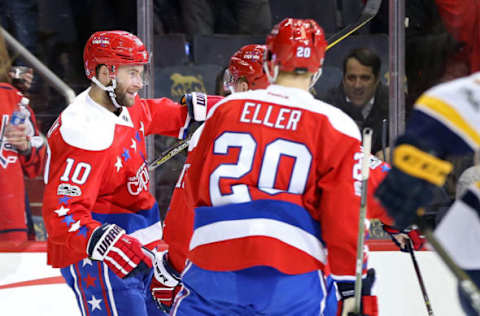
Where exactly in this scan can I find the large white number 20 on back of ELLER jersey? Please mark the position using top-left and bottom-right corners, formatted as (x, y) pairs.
(210, 132), (312, 206)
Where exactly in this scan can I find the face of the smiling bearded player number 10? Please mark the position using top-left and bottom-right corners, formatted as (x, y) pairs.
(115, 65), (144, 107)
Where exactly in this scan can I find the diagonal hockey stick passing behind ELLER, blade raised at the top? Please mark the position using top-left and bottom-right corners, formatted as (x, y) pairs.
(148, 0), (382, 171)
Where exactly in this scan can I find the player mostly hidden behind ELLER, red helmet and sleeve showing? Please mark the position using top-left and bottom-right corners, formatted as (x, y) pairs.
(152, 44), (269, 311)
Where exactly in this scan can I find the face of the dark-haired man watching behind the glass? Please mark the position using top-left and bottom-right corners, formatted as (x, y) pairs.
(343, 58), (378, 107)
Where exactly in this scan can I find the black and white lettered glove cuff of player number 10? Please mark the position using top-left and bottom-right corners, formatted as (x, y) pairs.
(87, 224), (125, 260)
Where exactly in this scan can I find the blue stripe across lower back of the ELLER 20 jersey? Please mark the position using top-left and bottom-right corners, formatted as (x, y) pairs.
(195, 200), (321, 242)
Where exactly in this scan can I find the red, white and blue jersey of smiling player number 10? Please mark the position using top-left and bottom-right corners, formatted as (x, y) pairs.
(42, 90), (197, 267)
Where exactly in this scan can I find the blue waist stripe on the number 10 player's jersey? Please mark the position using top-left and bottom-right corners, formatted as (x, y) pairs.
(92, 202), (160, 234)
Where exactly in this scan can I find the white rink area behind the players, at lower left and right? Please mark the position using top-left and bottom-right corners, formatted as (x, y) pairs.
(0, 251), (463, 316)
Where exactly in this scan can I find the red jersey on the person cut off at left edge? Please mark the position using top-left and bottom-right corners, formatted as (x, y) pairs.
(0, 83), (46, 241)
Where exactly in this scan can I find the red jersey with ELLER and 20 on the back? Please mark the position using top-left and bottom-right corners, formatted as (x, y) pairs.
(185, 85), (390, 280)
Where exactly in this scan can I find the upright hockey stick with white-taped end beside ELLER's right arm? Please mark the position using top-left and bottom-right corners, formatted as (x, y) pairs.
(354, 127), (373, 315)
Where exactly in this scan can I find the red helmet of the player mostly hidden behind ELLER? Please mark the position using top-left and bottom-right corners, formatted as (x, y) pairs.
(226, 44), (269, 90)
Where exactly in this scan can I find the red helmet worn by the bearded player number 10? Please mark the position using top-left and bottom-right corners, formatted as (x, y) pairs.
(83, 31), (149, 79)
